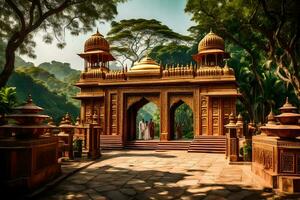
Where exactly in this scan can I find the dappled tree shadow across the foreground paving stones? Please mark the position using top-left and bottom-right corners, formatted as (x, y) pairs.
(33, 162), (286, 200)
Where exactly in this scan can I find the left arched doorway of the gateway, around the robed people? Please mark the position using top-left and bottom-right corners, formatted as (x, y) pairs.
(126, 98), (160, 141)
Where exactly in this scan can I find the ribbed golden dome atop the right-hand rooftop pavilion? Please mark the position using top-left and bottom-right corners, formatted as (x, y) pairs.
(198, 31), (225, 53)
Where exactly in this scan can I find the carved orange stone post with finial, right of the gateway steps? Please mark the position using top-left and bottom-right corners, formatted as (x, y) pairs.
(225, 113), (239, 162)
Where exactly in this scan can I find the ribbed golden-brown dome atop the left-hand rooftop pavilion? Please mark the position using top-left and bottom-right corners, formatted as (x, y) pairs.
(84, 30), (109, 52)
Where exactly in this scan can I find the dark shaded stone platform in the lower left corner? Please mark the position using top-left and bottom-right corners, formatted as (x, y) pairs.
(0, 137), (61, 193)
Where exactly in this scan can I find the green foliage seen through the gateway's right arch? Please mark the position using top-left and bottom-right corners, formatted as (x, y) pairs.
(173, 103), (194, 139)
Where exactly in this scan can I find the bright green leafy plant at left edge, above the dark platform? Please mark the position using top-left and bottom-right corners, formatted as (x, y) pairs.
(0, 87), (17, 115)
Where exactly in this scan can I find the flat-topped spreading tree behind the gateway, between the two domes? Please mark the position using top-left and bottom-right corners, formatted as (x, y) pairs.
(107, 19), (191, 67)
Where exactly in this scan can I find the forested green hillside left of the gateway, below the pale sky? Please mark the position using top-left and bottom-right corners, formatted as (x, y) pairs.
(0, 40), (80, 122)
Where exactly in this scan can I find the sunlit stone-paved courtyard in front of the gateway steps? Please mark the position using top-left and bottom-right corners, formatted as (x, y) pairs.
(40, 150), (274, 200)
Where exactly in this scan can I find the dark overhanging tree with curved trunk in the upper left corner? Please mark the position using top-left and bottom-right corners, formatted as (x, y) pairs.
(0, 0), (124, 87)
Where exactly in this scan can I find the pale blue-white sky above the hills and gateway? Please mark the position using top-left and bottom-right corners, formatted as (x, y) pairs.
(21, 0), (194, 70)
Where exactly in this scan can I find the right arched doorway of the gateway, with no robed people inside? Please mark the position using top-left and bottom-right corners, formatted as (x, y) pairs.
(170, 100), (194, 140)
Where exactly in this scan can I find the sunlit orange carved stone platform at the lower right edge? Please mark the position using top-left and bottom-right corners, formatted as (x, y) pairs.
(252, 135), (300, 192)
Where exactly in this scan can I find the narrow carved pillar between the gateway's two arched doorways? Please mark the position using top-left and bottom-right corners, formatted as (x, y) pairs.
(160, 91), (170, 140)
